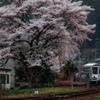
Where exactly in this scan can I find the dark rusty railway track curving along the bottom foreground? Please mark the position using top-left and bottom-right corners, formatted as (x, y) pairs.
(0, 88), (100, 100)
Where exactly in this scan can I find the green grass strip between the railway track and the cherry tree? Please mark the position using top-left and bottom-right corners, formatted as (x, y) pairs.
(0, 87), (85, 98)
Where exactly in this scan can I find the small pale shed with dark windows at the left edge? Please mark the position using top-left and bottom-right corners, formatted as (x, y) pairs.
(0, 59), (15, 89)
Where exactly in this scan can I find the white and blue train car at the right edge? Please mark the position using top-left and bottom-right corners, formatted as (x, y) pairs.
(82, 62), (100, 83)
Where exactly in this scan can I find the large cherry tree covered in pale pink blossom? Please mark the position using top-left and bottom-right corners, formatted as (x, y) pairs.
(0, 0), (95, 86)
